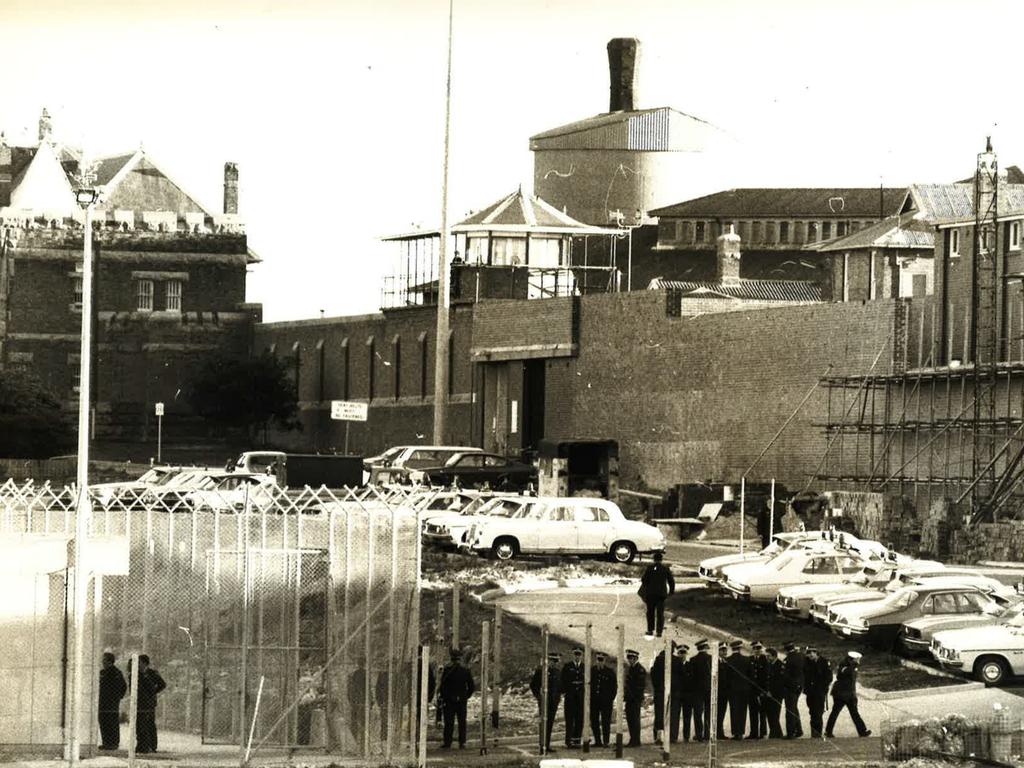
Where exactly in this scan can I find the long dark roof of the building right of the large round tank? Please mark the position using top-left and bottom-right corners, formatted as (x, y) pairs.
(650, 186), (906, 218)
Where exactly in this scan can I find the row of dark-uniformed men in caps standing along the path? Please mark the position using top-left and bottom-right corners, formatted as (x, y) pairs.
(529, 640), (870, 752)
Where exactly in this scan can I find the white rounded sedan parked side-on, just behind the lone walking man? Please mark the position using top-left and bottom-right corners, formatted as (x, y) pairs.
(467, 497), (665, 563)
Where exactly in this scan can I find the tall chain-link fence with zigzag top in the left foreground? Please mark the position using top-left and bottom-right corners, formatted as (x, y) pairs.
(0, 481), (420, 759)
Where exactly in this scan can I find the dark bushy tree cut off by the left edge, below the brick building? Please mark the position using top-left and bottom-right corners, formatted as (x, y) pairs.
(0, 371), (75, 459)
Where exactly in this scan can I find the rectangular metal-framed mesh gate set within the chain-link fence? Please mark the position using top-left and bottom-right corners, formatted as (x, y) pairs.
(203, 549), (331, 749)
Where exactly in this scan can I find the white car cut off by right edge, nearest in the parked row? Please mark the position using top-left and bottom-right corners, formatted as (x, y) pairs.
(931, 616), (1024, 686)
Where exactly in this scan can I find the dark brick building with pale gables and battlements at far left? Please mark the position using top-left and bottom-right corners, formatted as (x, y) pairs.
(0, 113), (261, 441)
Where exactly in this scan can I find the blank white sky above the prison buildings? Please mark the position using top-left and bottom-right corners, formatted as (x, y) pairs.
(6, 0), (1024, 321)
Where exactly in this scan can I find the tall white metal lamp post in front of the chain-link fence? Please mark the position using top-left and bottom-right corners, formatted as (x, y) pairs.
(68, 182), (99, 766)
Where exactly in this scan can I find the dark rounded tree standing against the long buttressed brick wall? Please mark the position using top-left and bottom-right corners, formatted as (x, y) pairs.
(185, 353), (302, 436)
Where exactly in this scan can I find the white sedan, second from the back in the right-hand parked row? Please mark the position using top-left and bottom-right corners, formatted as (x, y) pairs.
(723, 542), (866, 603)
